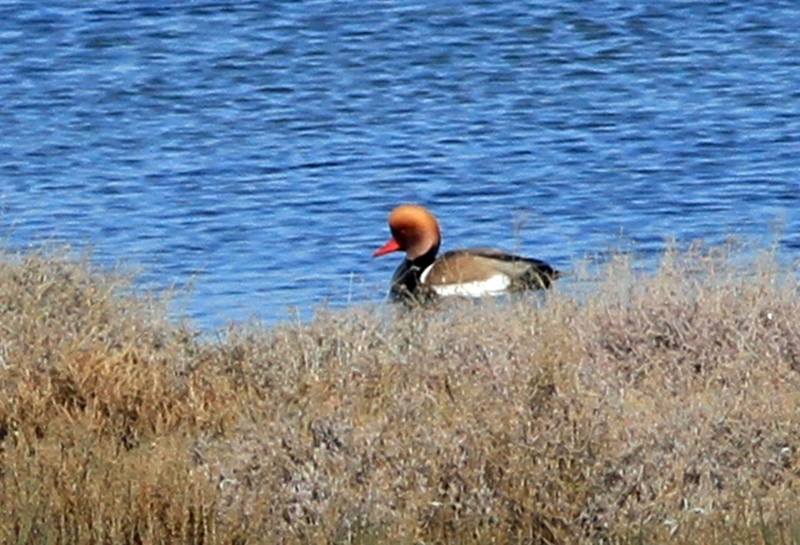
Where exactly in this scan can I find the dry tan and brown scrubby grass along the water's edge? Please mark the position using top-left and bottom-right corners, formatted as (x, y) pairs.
(0, 248), (800, 544)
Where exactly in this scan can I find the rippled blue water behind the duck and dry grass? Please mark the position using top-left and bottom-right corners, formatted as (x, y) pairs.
(0, 0), (800, 329)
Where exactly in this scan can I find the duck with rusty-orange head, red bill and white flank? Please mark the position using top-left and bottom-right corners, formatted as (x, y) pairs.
(372, 204), (563, 303)
